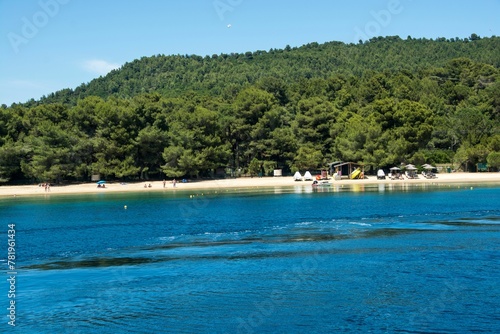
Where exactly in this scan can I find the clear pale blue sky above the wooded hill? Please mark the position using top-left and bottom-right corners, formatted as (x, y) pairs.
(0, 0), (500, 105)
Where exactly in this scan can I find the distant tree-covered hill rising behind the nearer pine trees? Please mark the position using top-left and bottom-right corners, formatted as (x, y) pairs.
(34, 35), (500, 104)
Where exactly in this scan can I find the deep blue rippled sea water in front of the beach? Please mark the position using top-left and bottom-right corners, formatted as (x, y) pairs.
(0, 182), (500, 334)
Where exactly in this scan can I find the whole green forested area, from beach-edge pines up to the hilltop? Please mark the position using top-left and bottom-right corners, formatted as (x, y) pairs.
(0, 35), (500, 182)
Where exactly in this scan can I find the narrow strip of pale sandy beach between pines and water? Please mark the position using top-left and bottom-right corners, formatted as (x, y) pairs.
(0, 172), (500, 198)
